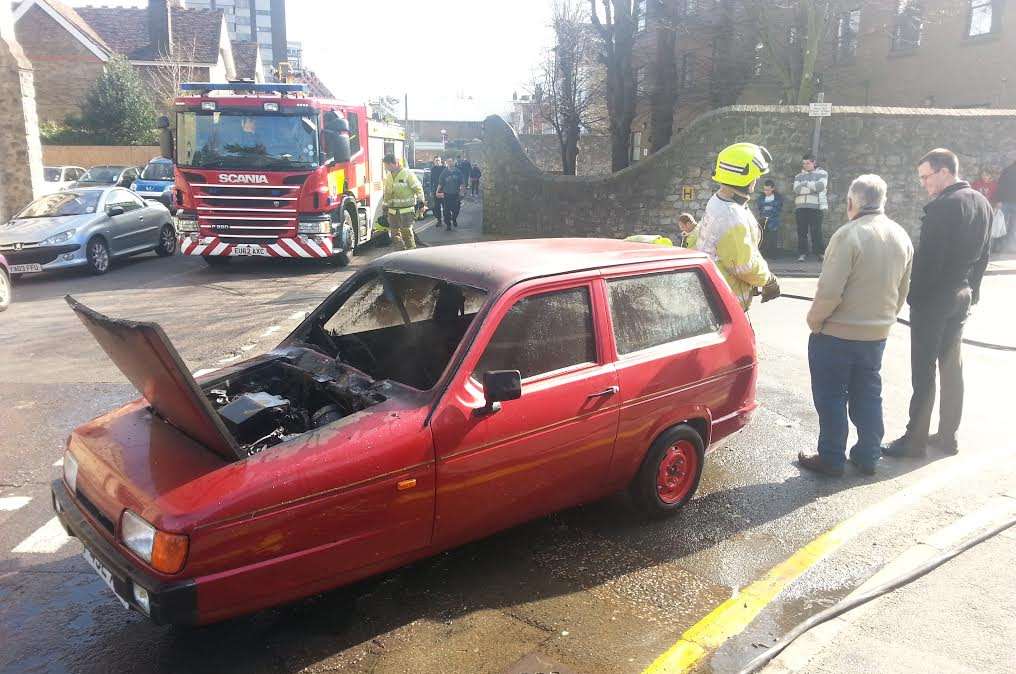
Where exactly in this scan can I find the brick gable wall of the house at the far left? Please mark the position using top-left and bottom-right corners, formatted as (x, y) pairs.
(16, 6), (103, 122)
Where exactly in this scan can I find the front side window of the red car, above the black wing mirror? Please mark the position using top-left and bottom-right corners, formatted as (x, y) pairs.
(473, 286), (596, 380)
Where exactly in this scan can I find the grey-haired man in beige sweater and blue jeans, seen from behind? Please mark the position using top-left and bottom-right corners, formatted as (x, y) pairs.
(798, 175), (913, 477)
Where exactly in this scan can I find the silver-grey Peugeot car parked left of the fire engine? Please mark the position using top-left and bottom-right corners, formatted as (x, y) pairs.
(0, 187), (177, 274)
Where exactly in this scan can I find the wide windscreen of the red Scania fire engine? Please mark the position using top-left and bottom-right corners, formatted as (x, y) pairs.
(177, 112), (319, 171)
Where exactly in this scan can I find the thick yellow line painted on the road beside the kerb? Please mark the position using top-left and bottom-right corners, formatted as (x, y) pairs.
(642, 450), (1006, 674)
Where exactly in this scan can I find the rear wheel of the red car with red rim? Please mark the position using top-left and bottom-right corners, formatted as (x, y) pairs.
(629, 424), (705, 517)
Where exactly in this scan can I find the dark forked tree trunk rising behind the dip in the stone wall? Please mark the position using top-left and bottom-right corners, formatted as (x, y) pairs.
(589, 0), (641, 171)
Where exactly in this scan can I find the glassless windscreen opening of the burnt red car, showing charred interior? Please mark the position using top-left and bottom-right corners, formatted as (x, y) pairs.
(302, 270), (486, 390)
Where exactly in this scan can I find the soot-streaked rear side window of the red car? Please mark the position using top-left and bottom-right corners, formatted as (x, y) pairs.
(607, 270), (720, 355)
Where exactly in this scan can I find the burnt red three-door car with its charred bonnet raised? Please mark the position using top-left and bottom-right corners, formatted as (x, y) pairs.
(53, 239), (756, 624)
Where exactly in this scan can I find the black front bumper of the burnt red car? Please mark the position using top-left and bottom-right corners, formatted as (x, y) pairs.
(51, 480), (197, 625)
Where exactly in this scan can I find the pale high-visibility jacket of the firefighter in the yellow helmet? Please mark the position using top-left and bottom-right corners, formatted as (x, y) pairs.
(695, 194), (773, 311)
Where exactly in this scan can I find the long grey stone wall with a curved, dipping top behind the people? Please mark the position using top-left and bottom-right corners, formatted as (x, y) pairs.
(484, 106), (1016, 248)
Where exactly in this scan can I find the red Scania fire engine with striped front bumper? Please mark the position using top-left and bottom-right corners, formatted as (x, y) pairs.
(160, 82), (405, 264)
